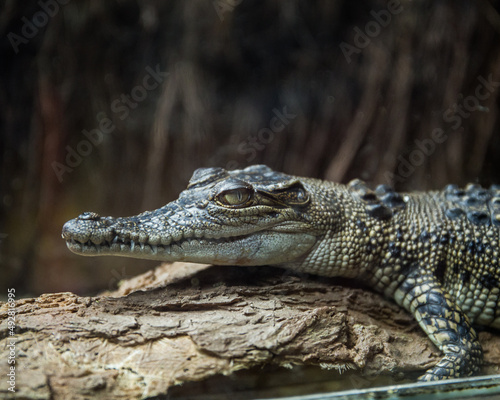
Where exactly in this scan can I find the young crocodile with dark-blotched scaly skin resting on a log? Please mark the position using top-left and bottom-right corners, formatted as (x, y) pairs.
(62, 165), (500, 381)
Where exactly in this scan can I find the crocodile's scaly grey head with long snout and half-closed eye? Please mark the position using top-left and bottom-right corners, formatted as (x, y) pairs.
(62, 165), (336, 265)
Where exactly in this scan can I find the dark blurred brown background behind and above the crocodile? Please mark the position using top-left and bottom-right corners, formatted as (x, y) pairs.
(0, 0), (500, 296)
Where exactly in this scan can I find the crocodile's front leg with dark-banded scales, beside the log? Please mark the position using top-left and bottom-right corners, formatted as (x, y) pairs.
(394, 270), (483, 381)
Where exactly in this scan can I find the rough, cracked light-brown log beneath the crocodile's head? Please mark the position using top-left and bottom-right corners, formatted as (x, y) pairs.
(0, 263), (500, 399)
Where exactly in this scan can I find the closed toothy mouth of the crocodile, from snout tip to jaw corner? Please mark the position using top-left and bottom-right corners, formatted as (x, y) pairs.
(62, 209), (316, 265)
